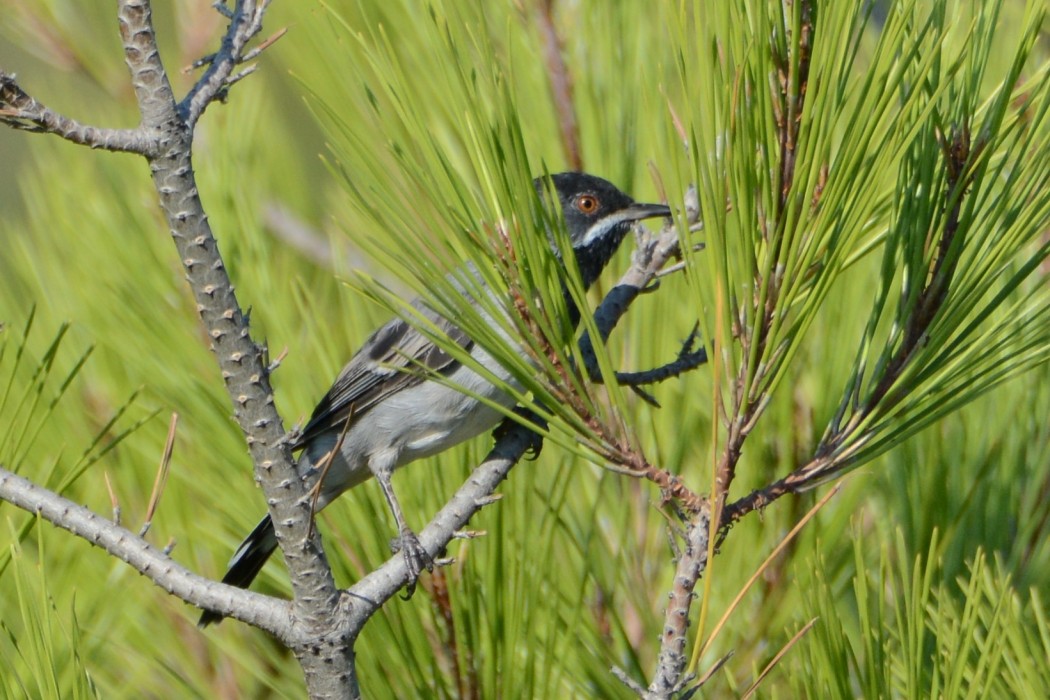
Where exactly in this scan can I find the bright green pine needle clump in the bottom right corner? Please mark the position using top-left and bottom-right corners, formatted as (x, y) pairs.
(789, 532), (1050, 698)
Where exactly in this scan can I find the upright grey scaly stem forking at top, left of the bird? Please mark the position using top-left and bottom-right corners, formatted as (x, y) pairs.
(110, 0), (342, 667)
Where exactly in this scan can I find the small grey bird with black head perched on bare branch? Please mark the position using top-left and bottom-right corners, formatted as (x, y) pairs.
(198, 172), (671, 629)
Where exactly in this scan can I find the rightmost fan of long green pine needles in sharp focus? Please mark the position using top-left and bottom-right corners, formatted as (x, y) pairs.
(827, 5), (1050, 470)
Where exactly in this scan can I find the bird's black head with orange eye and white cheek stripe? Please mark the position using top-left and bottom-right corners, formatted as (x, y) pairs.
(536, 172), (671, 287)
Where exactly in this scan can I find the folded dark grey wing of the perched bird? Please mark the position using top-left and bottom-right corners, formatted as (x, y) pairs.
(293, 305), (473, 447)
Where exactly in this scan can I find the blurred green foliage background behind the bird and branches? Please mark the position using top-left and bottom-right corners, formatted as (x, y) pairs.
(0, 0), (1050, 698)
